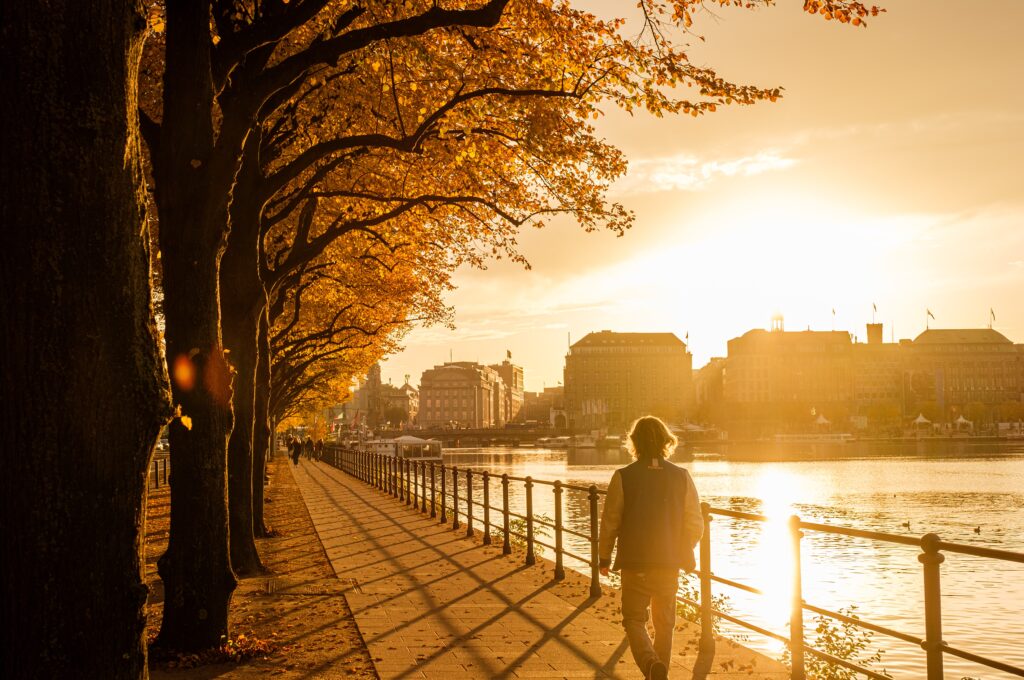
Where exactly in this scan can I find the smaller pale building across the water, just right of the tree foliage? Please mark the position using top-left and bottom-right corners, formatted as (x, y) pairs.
(419, 362), (509, 428)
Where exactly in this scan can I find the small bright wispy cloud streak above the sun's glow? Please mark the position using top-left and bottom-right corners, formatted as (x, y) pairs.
(614, 150), (798, 195)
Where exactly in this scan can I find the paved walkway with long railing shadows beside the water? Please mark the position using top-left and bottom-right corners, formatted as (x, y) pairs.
(294, 461), (787, 680)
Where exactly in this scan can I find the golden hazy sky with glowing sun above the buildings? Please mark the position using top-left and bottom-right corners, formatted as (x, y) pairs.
(383, 0), (1024, 390)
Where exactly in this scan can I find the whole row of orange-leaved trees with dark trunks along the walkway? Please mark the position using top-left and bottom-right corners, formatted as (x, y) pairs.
(0, 0), (877, 678)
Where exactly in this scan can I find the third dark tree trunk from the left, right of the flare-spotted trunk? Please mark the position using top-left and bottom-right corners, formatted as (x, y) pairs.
(220, 219), (266, 575)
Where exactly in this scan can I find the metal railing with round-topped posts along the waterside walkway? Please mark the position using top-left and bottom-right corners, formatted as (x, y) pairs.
(324, 447), (1024, 680)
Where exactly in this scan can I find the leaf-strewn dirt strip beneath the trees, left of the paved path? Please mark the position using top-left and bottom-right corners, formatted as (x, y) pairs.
(145, 456), (378, 680)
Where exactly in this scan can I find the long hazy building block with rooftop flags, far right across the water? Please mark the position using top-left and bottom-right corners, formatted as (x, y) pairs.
(694, 318), (1024, 436)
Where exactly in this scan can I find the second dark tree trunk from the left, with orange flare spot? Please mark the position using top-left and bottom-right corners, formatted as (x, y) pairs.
(154, 3), (241, 651)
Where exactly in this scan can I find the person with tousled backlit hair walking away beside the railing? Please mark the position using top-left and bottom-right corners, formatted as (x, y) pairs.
(600, 416), (703, 680)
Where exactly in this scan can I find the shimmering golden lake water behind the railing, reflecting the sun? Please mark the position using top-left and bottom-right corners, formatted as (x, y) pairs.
(444, 445), (1024, 680)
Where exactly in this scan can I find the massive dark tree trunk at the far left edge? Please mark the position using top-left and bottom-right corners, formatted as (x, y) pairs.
(0, 0), (170, 679)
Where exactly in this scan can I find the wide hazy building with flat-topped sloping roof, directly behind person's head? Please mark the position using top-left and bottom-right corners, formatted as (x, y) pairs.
(564, 331), (693, 432)
